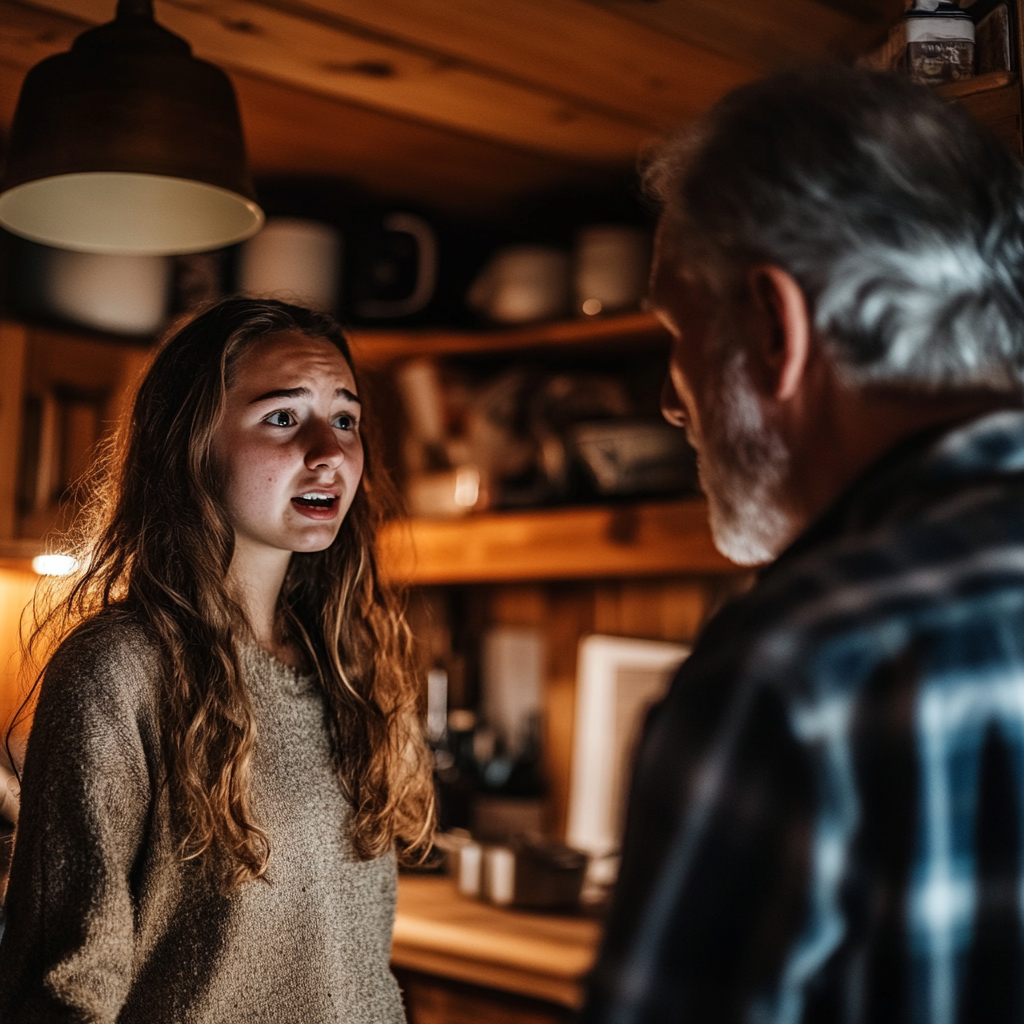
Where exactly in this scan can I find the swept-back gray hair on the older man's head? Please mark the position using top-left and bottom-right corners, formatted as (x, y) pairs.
(645, 69), (1024, 391)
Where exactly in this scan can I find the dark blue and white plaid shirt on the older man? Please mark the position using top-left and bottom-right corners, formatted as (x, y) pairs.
(584, 411), (1024, 1024)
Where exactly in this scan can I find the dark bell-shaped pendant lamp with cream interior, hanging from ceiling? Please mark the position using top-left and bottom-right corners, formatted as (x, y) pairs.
(0, 0), (263, 255)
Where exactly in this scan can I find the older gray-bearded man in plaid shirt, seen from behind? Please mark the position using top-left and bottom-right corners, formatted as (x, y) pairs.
(584, 70), (1024, 1024)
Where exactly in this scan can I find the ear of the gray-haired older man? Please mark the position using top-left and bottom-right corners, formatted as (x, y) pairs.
(746, 263), (811, 401)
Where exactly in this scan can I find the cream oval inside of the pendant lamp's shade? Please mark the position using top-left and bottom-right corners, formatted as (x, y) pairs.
(0, 171), (263, 256)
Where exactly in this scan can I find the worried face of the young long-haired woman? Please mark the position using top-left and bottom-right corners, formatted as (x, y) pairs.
(213, 331), (362, 552)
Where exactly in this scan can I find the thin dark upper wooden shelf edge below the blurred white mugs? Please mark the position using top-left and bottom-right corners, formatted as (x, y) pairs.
(348, 312), (669, 370)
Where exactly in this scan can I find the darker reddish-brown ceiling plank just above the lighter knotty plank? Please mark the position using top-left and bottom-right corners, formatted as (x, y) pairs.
(255, 0), (764, 126)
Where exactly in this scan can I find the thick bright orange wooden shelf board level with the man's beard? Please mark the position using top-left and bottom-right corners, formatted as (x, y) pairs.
(379, 499), (736, 585)
